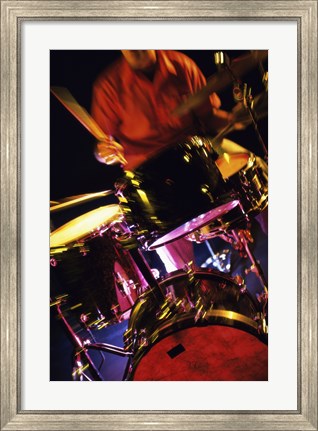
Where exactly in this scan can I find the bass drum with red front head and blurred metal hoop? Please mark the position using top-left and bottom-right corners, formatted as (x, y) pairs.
(125, 270), (268, 381)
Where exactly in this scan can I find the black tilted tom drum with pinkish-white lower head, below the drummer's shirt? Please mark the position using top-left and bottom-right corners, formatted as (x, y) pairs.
(117, 136), (234, 249)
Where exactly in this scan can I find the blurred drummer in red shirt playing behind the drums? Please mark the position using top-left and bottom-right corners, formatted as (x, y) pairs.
(91, 50), (262, 272)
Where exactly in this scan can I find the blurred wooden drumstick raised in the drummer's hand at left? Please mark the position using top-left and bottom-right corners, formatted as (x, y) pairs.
(51, 87), (127, 164)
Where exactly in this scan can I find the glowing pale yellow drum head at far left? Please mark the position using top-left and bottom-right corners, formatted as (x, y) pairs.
(50, 204), (122, 248)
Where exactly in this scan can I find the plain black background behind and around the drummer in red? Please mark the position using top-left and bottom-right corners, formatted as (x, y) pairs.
(50, 50), (267, 200)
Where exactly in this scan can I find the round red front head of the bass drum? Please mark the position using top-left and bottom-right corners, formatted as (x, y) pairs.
(133, 325), (268, 381)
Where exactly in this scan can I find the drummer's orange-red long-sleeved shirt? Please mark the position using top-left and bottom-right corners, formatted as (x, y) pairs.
(91, 51), (220, 169)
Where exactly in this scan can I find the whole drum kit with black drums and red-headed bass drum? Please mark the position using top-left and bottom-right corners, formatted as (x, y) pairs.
(50, 50), (268, 381)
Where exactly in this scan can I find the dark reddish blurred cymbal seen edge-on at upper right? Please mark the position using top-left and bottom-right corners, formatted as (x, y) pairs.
(173, 50), (268, 117)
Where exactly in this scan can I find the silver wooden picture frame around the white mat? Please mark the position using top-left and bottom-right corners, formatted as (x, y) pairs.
(1, 0), (318, 430)
